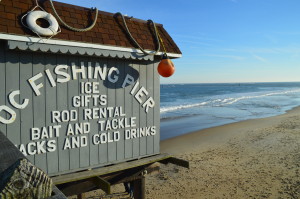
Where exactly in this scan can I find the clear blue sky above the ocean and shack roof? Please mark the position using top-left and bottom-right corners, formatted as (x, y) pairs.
(59, 0), (300, 83)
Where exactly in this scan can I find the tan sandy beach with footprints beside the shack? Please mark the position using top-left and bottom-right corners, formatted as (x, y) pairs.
(147, 107), (300, 199)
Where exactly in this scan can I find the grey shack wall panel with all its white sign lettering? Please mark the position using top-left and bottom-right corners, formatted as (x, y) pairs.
(0, 46), (159, 175)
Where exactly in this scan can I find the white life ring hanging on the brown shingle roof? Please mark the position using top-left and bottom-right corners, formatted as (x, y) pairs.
(26, 11), (59, 36)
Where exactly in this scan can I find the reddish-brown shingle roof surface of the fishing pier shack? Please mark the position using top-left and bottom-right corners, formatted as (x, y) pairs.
(0, 0), (181, 54)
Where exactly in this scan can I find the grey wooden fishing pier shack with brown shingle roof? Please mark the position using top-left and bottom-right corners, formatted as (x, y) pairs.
(0, 0), (181, 176)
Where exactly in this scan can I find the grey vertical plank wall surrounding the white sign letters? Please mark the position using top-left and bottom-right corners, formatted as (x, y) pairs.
(0, 41), (160, 176)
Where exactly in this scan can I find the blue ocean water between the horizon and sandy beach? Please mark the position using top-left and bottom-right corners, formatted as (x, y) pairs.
(160, 82), (300, 140)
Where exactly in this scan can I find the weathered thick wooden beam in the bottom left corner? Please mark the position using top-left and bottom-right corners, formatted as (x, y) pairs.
(0, 132), (52, 199)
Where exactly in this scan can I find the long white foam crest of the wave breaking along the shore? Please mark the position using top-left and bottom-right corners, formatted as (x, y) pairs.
(160, 89), (300, 113)
